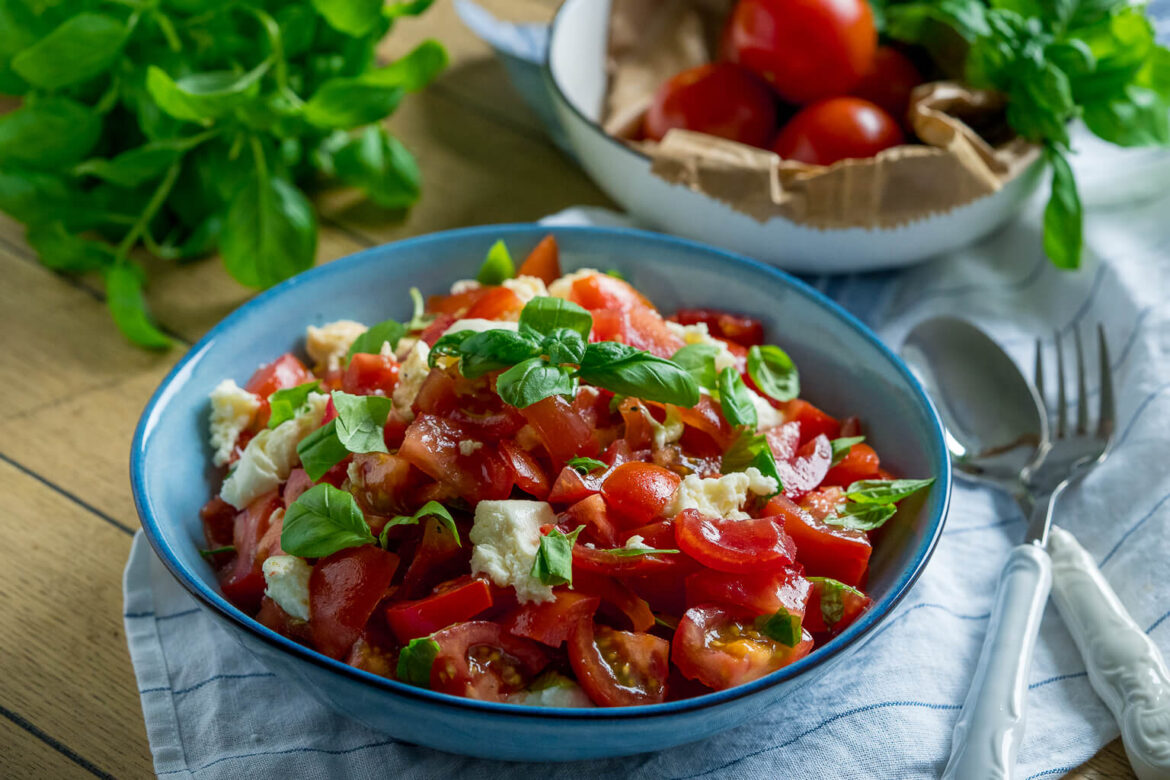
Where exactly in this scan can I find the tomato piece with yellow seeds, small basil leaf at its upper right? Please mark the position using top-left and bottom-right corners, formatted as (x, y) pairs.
(670, 605), (812, 690)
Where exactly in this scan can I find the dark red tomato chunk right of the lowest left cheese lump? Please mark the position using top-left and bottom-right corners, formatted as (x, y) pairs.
(309, 545), (398, 658)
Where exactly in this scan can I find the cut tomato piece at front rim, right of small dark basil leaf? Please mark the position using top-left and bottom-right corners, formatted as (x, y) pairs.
(431, 620), (549, 702)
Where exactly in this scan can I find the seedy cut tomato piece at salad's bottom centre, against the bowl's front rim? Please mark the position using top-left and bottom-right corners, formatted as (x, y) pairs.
(569, 617), (670, 706)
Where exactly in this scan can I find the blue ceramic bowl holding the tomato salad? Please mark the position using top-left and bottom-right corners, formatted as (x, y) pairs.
(130, 225), (951, 760)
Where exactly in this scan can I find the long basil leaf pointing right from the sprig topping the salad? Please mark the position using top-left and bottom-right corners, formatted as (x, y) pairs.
(578, 341), (698, 408)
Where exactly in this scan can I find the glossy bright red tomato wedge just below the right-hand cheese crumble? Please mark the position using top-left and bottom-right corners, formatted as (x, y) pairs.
(674, 509), (797, 573)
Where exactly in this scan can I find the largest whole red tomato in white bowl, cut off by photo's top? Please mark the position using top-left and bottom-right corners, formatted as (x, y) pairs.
(722, 0), (878, 103)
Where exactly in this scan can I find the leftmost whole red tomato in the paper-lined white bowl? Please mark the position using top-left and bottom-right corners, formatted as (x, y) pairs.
(645, 62), (776, 147)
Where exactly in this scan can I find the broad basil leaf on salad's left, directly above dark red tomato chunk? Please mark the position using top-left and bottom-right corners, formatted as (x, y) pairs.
(281, 483), (376, 558)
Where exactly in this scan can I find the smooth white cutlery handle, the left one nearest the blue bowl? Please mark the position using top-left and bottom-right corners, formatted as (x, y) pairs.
(943, 544), (1052, 780)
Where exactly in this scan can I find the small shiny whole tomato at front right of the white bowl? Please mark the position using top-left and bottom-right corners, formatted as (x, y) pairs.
(772, 97), (906, 165)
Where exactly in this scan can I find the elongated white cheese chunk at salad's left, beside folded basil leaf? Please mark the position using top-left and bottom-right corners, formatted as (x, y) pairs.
(220, 393), (329, 509)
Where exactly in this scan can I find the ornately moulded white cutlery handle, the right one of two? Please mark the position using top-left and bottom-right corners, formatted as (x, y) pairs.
(1048, 526), (1170, 780)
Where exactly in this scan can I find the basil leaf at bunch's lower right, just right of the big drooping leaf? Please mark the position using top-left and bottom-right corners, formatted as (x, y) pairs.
(333, 125), (422, 208)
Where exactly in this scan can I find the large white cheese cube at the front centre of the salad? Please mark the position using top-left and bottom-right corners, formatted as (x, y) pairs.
(468, 499), (557, 603)
